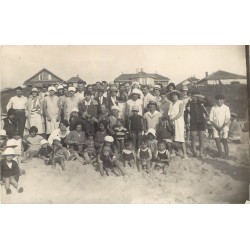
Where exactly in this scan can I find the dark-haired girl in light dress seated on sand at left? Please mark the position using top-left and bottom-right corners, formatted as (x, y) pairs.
(22, 126), (43, 162)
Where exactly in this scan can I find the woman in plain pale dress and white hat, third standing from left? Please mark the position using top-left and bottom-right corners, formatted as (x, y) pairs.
(43, 87), (61, 136)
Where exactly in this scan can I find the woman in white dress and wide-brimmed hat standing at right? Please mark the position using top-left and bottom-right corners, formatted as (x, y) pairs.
(168, 90), (187, 159)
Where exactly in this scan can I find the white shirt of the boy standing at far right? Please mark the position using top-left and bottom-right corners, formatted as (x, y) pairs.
(209, 104), (231, 131)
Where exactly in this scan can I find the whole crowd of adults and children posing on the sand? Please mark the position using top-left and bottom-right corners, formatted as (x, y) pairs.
(0, 81), (240, 194)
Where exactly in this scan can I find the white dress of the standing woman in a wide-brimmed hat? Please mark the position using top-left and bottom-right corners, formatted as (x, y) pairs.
(168, 100), (185, 142)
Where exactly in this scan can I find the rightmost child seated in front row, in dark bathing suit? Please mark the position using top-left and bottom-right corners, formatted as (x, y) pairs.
(152, 140), (170, 174)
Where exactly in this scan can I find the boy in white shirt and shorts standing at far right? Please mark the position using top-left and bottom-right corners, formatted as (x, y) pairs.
(209, 95), (231, 159)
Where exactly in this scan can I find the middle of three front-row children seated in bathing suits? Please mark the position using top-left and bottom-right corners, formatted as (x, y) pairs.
(137, 139), (152, 173)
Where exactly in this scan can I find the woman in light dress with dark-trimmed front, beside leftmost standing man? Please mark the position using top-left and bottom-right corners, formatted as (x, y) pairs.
(26, 88), (44, 135)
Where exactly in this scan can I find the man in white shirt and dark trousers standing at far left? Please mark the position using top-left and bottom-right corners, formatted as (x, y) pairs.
(6, 86), (27, 137)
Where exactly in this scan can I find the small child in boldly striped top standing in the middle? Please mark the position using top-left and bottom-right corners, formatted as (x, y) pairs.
(113, 118), (128, 153)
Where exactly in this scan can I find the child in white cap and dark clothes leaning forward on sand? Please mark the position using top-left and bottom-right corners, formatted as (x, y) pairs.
(98, 136), (127, 176)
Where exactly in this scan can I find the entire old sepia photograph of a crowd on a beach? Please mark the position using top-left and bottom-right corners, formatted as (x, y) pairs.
(0, 45), (250, 204)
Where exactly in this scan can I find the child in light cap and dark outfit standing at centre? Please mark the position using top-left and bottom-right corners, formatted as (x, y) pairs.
(128, 105), (144, 149)
